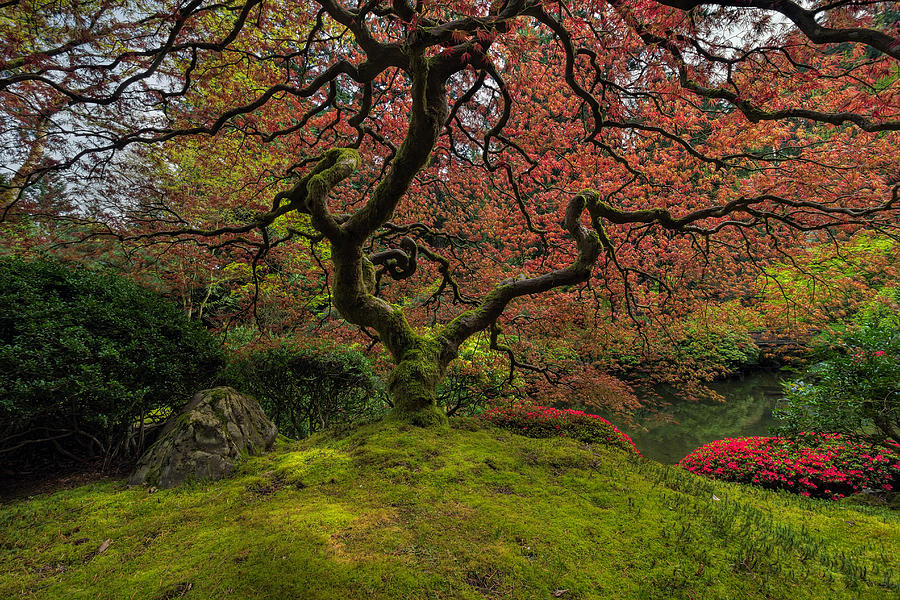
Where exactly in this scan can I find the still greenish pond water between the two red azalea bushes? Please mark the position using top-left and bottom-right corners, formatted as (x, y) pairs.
(609, 372), (787, 464)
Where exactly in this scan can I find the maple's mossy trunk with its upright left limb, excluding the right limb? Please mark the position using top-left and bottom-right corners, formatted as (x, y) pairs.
(303, 51), (455, 426)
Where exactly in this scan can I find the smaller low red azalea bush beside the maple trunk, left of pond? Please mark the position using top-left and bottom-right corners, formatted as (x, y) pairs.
(482, 404), (641, 456)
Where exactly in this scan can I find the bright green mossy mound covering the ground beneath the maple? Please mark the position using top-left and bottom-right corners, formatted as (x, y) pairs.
(0, 419), (900, 600)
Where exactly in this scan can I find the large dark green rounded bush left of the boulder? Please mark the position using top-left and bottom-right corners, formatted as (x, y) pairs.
(0, 257), (224, 460)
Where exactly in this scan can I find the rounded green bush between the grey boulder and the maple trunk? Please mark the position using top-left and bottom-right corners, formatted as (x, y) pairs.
(226, 346), (386, 438)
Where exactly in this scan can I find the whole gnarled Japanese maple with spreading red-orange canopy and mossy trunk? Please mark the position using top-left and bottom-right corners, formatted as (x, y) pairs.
(0, 0), (900, 424)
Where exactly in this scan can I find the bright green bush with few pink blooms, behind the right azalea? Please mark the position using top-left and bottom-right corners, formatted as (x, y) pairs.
(776, 312), (900, 443)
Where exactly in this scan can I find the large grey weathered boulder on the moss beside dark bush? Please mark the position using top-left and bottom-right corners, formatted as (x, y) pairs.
(128, 387), (277, 488)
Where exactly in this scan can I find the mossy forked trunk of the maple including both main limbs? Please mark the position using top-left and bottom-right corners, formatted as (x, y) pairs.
(278, 43), (601, 426)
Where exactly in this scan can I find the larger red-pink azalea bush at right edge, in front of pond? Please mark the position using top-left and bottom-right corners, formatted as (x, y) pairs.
(679, 433), (900, 500)
